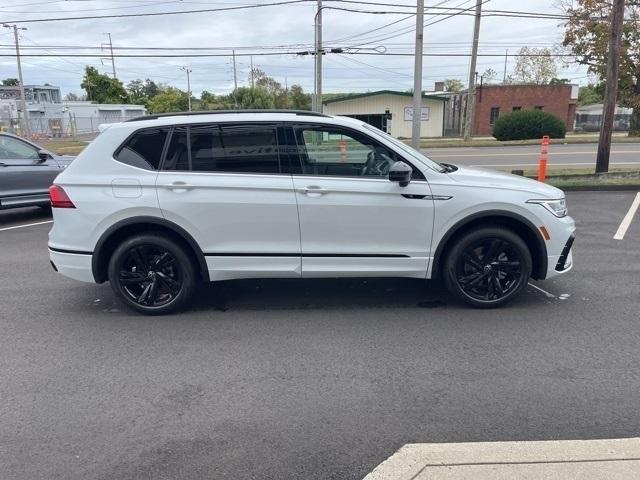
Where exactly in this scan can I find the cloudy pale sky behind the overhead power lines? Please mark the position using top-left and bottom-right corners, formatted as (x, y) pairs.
(0, 0), (588, 95)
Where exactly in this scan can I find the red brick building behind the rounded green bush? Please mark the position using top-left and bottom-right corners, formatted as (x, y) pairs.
(473, 85), (578, 136)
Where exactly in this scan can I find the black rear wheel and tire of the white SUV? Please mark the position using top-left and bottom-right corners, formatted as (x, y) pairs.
(108, 233), (196, 315)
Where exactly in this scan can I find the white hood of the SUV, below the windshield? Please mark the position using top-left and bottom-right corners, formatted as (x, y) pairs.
(448, 165), (564, 199)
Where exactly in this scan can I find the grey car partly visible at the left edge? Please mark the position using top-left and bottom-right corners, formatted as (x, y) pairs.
(0, 132), (74, 210)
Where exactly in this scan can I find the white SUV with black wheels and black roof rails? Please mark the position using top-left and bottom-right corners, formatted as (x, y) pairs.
(49, 111), (575, 314)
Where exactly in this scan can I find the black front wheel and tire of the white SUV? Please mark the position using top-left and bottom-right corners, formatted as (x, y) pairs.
(443, 226), (532, 308)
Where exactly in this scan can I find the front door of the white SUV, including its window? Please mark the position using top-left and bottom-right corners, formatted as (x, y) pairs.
(293, 125), (434, 278)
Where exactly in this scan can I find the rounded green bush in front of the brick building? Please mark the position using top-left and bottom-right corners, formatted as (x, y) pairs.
(493, 110), (567, 141)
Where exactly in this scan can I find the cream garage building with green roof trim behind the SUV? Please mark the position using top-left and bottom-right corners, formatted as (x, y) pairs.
(323, 90), (447, 138)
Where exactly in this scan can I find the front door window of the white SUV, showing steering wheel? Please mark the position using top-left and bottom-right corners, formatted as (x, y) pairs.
(296, 127), (396, 177)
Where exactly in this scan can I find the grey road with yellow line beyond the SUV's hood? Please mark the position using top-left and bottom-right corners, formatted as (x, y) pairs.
(422, 143), (640, 168)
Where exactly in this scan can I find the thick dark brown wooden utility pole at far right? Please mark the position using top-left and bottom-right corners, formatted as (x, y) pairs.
(596, 0), (624, 173)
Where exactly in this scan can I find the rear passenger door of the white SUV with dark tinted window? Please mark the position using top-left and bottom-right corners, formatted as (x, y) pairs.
(156, 123), (300, 280)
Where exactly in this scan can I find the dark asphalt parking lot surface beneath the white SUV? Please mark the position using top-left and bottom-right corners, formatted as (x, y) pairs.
(0, 192), (640, 480)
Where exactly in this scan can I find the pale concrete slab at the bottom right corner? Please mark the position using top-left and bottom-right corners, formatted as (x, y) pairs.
(364, 438), (640, 480)
